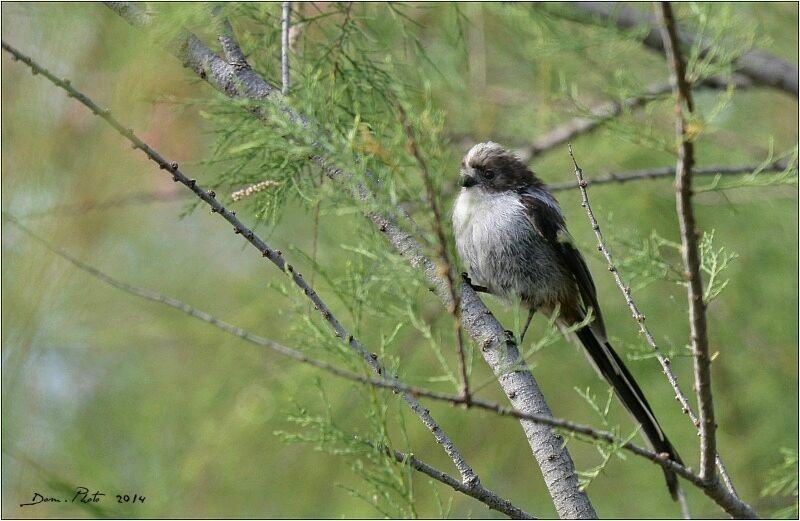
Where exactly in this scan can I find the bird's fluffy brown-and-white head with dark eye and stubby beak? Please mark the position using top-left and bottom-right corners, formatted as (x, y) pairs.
(460, 141), (542, 192)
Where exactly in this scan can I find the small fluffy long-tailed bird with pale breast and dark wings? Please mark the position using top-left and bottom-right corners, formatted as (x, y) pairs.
(453, 142), (682, 499)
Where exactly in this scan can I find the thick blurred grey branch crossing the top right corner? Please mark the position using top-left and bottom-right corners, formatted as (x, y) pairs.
(572, 2), (798, 97)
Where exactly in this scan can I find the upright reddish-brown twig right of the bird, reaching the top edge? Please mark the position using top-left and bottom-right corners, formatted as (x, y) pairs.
(657, 2), (717, 482)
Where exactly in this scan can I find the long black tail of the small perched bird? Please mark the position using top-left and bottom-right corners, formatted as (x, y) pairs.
(576, 325), (683, 500)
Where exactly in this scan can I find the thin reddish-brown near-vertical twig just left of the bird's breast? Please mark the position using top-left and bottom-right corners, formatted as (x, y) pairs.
(397, 103), (470, 407)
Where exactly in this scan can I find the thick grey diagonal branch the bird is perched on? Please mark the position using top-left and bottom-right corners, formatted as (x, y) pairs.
(98, 6), (597, 518)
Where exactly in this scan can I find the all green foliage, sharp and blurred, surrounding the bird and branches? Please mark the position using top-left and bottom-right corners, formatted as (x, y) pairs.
(2, 3), (798, 518)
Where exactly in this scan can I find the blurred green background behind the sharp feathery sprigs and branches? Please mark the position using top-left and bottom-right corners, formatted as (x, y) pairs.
(2, 2), (798, 518)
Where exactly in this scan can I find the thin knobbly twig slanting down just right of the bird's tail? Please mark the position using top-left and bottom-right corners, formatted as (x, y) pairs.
(567, 145), (757, 518)
